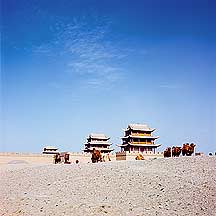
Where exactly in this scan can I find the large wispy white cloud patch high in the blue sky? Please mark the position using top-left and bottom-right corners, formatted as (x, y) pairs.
(34, 17), (130, 86)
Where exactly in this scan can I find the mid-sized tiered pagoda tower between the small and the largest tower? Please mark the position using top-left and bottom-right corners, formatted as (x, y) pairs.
(83, 133), (113, 153)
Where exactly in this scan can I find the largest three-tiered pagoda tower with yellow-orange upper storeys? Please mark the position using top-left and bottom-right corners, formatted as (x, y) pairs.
(118, 124), (161, 154)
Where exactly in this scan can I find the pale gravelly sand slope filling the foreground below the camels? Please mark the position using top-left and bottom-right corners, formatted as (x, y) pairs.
(0, 156), (216, 216)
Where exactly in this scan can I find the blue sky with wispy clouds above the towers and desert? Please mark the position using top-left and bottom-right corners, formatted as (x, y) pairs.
(0, 0), (216, 153)
